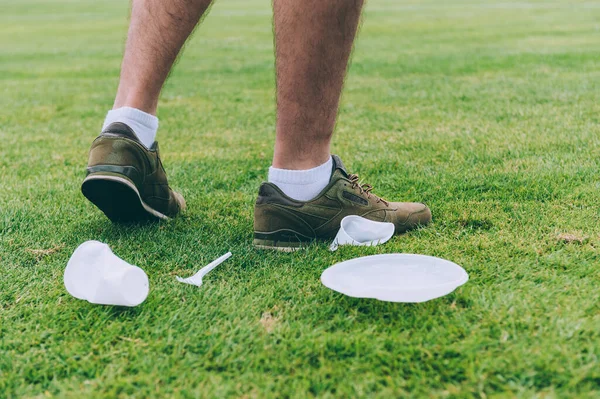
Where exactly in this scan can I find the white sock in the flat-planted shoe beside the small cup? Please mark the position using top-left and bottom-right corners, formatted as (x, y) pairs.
(269, 157), (333, 201)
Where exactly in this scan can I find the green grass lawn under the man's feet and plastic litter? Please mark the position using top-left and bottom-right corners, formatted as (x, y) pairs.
(0, 0), (600, 398)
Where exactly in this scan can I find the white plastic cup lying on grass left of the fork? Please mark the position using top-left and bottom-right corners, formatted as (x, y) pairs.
(64, 241), (150, 306)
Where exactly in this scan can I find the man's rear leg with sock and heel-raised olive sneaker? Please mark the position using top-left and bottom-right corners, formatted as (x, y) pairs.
(82, 0), (211, 221)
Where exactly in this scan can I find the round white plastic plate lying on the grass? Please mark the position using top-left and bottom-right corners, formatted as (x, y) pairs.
(321, 254), (469, 303)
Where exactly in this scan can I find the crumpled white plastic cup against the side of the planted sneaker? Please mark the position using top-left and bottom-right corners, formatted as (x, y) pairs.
(329, 215), (395, 251)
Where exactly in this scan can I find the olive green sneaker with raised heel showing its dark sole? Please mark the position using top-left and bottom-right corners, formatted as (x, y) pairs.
(81, 123), (185, 222)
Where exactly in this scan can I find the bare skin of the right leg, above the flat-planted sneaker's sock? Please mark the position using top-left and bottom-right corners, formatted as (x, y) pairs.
(273, 0), (363, 169)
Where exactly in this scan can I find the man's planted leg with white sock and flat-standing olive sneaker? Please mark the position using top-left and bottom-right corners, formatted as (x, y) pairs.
(254, 0), (431, 251)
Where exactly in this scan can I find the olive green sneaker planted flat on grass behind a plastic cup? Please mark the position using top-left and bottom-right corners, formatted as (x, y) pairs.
(254, 155), (431, 251)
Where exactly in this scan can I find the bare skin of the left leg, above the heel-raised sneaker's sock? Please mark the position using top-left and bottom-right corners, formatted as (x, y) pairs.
(113, 0), (212, 115)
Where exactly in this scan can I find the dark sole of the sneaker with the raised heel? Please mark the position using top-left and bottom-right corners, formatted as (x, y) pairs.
(81, 175), (170, 223)
